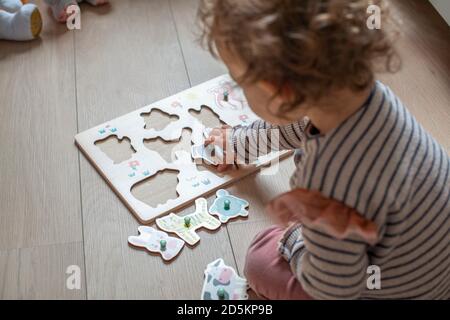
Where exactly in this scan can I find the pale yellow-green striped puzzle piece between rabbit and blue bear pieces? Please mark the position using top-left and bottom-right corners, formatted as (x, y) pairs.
(156, 198), (220, 245)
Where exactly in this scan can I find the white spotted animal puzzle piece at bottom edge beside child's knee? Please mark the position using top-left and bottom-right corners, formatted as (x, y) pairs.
(201, 259), (248, 300)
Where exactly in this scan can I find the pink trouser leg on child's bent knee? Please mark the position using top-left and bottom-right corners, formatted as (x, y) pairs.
(244, 226), (312, 300)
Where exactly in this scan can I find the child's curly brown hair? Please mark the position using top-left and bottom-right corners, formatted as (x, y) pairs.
(198, 0), (396, 113)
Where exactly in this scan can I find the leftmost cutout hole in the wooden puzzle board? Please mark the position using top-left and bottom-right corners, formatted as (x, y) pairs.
(94, 135), (136, 164)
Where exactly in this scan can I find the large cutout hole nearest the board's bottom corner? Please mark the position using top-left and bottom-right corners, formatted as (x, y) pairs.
(131, 169), (179, 208)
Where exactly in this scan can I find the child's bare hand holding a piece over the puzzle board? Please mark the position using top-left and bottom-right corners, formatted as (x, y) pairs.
(205, 125), (235, 172)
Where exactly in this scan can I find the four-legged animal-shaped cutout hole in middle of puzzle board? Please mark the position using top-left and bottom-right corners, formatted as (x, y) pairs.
(144, 128), (192, 162)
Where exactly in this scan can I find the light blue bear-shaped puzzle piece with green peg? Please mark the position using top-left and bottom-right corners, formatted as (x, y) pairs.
(209, 189), (249, 223)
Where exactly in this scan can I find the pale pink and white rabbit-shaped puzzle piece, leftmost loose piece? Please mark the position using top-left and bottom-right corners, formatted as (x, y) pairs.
(128, 226), (184, 261)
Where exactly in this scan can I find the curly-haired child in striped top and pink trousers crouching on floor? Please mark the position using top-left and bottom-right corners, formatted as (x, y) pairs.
(199, 0), (450, 299)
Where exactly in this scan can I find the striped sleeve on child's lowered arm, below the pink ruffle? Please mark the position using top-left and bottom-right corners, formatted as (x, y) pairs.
(290, 226), (369, 299)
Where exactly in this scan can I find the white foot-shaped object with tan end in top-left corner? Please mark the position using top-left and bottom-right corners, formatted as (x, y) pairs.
(0, 4), (42, 41)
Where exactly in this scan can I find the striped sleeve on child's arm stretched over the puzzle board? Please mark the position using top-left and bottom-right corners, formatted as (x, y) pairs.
(232, 118), (309, 164)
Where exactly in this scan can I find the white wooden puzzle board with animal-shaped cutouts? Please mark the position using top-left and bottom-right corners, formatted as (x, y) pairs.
(75, 75), (288, 223)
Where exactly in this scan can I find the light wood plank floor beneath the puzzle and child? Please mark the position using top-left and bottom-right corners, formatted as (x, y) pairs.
(0, 0), (450, 299)
